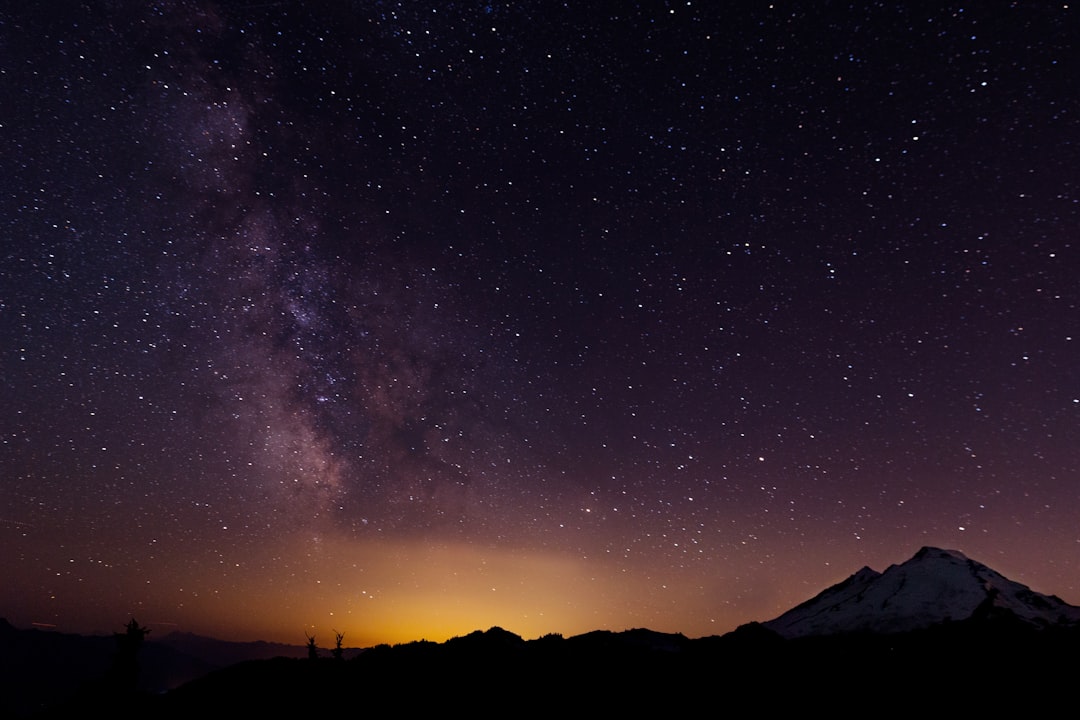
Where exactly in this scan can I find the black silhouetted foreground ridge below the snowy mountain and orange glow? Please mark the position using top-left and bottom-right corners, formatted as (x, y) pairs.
(21, 622), (1080, 718)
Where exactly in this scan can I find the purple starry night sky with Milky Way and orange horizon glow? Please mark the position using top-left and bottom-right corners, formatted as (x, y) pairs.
(0, 0), (1080, 644)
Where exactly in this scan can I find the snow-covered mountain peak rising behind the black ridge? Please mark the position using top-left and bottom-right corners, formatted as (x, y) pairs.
(762, 547), (1080, 638)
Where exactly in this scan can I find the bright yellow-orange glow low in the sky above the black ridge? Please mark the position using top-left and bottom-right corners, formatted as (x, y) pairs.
(130, 536), (756, 648)
